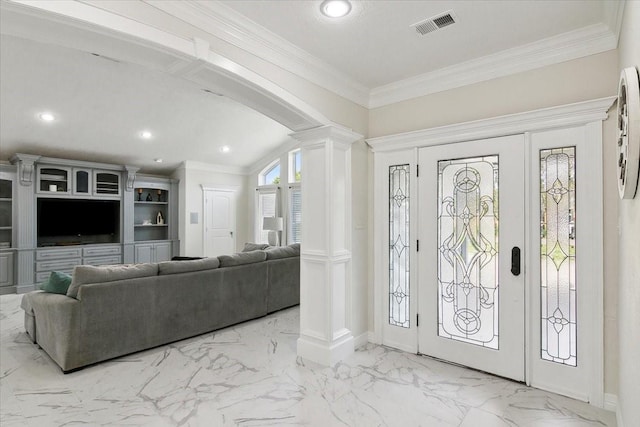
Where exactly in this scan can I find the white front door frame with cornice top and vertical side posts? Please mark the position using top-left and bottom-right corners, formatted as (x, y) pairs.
(367, 97), (616, 407)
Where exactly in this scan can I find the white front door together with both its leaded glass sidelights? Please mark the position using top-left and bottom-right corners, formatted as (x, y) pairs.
(372, 101), (604, 406)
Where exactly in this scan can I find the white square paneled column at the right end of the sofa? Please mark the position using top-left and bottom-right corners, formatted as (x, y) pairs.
(291, 126), (363, 366)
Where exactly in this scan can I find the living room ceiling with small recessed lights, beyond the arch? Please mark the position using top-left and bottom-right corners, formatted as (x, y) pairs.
(0, 31), (291, 173)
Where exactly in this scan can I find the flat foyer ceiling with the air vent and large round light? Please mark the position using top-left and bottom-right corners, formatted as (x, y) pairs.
(222, 0), (611, 89)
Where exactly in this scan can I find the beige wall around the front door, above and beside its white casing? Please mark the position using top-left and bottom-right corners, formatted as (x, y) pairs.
(369, 51), (624, 394)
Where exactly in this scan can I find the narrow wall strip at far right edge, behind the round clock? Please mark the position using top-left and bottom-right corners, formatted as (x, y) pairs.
(618, 1), (640, 427)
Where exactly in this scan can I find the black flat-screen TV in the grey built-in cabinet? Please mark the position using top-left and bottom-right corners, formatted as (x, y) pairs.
(37, 198), (120, 246)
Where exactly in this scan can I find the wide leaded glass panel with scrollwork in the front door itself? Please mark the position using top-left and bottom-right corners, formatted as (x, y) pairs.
(438, 156), (499, 349)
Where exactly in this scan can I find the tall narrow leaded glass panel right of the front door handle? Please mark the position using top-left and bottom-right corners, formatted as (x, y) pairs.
(540, 147), (577, 366)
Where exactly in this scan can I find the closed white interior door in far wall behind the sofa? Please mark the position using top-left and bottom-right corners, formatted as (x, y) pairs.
(204, 189), (236, 257)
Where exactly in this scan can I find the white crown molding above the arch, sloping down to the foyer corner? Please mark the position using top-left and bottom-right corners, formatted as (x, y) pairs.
(144, 0), (369, 107)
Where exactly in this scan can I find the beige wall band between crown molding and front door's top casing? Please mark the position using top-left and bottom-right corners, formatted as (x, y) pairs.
(369, 51), (618, 138)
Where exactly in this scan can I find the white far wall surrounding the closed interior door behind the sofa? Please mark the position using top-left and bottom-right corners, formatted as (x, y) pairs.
(173, 161), (249, 256)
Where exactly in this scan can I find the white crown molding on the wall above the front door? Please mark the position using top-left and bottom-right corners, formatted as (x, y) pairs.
(369, 24), (618, 108)
